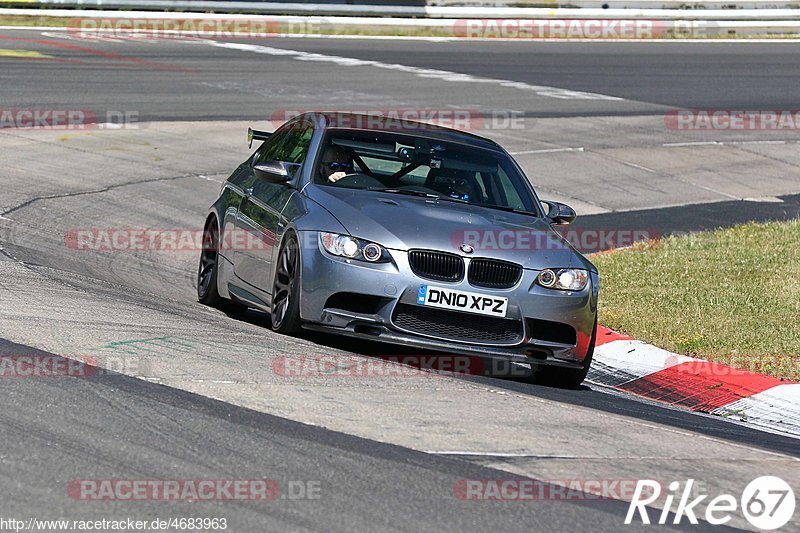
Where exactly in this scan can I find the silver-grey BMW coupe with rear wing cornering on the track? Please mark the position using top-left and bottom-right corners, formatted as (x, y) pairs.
(197, 113), (599, 387)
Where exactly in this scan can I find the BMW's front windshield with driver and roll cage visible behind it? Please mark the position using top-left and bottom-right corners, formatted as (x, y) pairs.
(315, 130), (537, 213)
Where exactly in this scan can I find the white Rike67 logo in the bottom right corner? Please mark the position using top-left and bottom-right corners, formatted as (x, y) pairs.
(625, 476), (795, 531)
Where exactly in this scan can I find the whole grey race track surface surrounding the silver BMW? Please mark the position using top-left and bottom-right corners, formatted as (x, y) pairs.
(0, 29), (800, 532)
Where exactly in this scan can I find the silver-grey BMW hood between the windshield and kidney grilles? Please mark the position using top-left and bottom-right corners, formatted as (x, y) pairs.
(305, 185), (593, 270)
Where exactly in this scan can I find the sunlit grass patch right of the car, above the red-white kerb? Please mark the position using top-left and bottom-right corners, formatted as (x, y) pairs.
(593, 220), (800, 380)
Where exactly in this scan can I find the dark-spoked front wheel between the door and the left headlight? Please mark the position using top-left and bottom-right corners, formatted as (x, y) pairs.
(270, 233), (300, 335)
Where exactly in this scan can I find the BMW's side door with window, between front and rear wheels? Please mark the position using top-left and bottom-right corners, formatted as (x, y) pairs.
(234, 120), (314, 293)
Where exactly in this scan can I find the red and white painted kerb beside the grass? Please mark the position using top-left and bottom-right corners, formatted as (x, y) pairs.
(587, 326), (800, 438)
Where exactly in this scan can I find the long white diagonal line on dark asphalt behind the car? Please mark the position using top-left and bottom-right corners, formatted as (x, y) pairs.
(204, 40), (623, 101)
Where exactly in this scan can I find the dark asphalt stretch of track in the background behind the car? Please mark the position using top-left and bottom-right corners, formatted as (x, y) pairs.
(0, 34), (800, 120)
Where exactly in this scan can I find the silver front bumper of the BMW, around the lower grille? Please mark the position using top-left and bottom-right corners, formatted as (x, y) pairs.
(300, 232), (598, 368)
